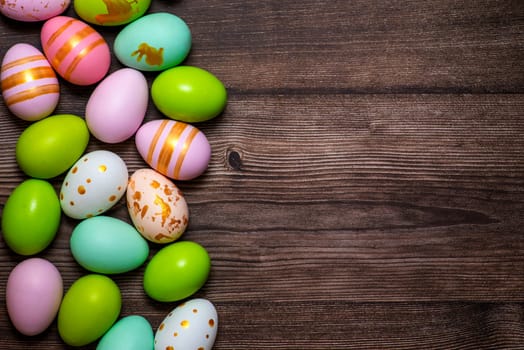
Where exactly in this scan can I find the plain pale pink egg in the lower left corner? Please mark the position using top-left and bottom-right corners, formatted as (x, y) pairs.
(6, 258), (63, 336)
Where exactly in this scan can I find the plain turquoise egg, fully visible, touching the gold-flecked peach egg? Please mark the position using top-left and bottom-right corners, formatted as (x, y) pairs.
(70, 216), (149, 274)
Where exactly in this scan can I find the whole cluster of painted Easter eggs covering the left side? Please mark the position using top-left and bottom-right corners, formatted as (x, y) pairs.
(0, 0), (227, 350)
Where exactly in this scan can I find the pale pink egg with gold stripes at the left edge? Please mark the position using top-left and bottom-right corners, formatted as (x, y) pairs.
(0, 43), (60, 121)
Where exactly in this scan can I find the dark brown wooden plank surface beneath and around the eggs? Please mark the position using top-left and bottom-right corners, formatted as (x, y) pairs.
(0, 0), (524, 349)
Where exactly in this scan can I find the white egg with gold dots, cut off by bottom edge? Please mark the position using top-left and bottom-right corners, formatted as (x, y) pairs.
(155, 298), (218, 350)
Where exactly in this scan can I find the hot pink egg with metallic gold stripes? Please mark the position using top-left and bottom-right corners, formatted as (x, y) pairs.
(40, 16), (111, 85)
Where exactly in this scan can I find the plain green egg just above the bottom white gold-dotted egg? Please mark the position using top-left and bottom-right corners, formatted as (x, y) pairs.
(144, 241), (211, 302)
